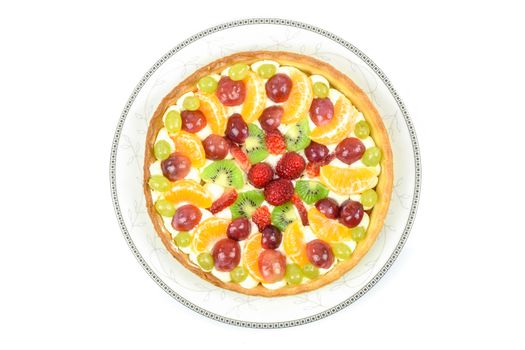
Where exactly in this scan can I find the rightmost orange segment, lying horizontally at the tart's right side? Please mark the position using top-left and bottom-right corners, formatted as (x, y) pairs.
(319, 165), (379, 195)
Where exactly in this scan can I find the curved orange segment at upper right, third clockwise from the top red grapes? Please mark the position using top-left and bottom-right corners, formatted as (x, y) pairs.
(310, 96), (358, 145)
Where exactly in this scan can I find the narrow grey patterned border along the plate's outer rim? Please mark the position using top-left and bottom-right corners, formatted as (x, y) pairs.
(109, 18), (421, 328)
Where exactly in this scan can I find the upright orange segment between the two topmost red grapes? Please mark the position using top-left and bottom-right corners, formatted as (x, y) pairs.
(241, 71), (266, 124)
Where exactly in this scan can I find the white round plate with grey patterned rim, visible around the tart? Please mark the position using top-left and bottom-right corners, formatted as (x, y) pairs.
(110, 19), (421, 328)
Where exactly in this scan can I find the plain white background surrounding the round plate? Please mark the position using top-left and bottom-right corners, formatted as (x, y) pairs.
(0, 0), (525, 349)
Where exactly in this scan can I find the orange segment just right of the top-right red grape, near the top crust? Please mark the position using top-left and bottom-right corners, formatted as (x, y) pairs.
(281, 67), (314, 124)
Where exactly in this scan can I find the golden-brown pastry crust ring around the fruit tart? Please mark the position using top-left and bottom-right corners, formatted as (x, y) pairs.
(144, 51), (393, 297)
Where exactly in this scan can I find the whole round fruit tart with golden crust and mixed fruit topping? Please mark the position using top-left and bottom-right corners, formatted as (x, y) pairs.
(144, 51), (393, 297)
